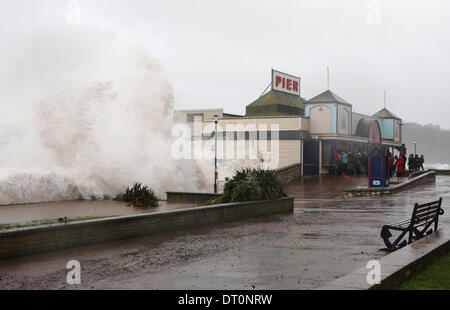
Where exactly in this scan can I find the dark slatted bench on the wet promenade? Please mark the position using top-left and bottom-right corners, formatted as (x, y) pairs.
(380, 198), (444, 251)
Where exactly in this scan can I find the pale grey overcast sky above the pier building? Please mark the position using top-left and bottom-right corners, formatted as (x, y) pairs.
(0, 0), (450, 128)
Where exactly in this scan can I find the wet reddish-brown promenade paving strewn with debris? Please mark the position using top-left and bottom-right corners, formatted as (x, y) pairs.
(0, 176), (450, 290)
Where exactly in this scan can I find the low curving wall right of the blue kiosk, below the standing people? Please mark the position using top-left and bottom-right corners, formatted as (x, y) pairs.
(342, 171), (436, 199)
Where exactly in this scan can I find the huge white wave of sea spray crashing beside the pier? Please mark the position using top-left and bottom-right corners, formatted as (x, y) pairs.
(0, 25), (212, 204)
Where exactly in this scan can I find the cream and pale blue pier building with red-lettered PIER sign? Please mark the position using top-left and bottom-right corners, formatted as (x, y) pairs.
(175, 71), (402, 175)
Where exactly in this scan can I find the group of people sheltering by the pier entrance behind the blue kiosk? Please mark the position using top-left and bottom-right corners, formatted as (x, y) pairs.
(329, 151), (368, 176)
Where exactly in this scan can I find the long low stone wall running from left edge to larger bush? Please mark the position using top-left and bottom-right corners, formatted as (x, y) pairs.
(0, 197), (294, 258)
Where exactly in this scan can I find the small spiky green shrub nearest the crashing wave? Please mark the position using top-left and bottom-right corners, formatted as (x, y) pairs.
(114, 183), (160, 208)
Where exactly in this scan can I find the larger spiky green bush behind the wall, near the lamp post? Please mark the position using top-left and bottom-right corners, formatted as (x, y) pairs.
(207, 169), (286, 204)
